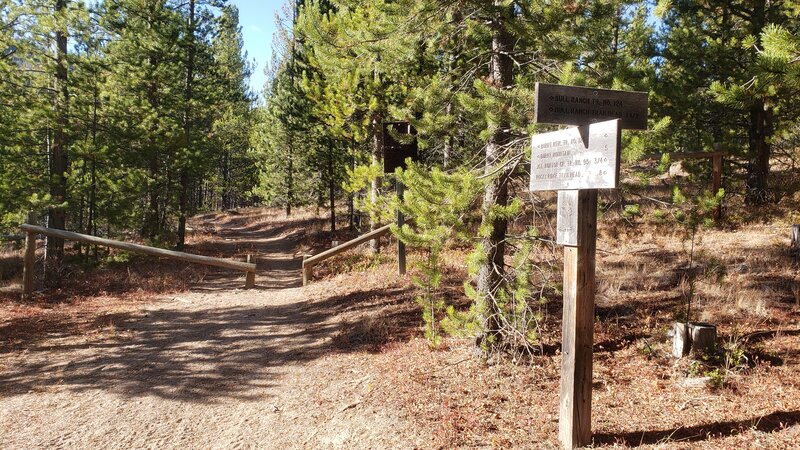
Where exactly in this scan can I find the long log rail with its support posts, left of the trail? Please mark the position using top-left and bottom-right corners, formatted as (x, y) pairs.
(20, 223), (256, 297)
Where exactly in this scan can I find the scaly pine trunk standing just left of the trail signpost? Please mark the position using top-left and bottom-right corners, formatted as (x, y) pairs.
(476, 6), (514, 348)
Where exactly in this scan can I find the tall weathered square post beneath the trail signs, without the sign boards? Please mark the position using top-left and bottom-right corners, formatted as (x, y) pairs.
(558, 189), (597, 449)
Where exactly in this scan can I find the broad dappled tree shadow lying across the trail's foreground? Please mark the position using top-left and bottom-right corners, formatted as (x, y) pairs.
(0, 289), (415, 403)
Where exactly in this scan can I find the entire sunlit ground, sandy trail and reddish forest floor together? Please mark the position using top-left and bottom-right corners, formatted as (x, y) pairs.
(0, 178), (800, 449)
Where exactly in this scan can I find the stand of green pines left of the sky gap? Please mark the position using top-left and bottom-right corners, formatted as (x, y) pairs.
(0, 0), (257, 260)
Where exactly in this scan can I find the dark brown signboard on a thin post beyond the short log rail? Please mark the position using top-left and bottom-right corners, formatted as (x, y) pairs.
(383, 122), (418, 275)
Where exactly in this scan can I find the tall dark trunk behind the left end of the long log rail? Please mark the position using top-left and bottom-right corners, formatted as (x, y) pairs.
(47, 0), (69, 267)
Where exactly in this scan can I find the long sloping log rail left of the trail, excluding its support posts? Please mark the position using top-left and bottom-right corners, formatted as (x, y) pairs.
(20, 224), (256, 272)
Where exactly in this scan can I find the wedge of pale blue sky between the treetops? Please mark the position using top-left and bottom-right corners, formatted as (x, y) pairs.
(230, 0), (285, 98)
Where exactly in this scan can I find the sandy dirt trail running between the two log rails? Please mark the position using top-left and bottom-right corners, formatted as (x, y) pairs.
(0, 216), (420, 449)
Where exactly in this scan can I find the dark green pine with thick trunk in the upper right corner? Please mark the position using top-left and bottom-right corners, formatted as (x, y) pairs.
(658, 0), (797, 203)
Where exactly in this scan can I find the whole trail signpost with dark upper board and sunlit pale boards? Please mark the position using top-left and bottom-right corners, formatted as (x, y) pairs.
(530, 83), (647, 449)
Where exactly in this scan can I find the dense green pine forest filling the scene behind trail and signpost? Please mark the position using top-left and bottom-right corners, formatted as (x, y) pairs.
(0, 0), (800, 341)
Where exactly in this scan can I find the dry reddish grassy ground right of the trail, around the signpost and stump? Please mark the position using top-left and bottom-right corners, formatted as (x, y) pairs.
(316, 178), (800, 449)
